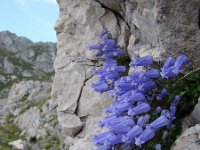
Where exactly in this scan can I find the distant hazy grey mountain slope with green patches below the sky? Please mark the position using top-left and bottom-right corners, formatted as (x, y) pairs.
(0, 31), (56, 97)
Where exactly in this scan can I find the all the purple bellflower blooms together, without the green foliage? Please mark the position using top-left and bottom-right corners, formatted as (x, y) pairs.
(88, 29), (187, 150)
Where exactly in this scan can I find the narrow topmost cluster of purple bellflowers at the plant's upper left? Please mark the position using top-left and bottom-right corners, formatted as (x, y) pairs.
(89, 29), (126, 93)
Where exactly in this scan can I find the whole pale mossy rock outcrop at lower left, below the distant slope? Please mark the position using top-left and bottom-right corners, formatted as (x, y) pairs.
(4, 80), (60, 150)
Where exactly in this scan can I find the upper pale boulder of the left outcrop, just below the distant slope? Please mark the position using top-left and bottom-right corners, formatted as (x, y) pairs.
(7, 80), (51, 116)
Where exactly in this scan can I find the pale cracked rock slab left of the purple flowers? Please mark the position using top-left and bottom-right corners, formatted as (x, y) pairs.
(52, 0), (116, 149)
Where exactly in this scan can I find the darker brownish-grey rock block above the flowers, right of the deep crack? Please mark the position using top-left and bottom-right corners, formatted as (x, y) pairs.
(124, 0), (200, 64)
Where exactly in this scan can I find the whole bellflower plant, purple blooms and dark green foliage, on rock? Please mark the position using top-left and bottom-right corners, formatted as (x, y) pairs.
(89, 29), (192, 150)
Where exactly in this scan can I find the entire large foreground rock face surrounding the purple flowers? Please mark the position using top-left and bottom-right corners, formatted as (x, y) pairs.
(52, 0), (200, 150)
